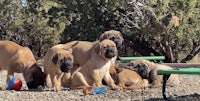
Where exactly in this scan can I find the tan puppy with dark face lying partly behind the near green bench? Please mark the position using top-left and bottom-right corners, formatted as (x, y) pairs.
(126, 59), (180, 87)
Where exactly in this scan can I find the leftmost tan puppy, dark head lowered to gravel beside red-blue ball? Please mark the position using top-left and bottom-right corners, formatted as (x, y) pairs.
(0, 41), (46, 88)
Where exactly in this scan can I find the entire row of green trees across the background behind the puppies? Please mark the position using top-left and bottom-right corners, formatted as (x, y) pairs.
(0, 0), (200, 62)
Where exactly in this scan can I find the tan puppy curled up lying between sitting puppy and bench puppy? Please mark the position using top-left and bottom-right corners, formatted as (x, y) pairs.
(110, 66), (149, 90)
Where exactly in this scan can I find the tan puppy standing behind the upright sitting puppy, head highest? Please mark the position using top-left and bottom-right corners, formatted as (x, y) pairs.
(72, 30), (124, 72)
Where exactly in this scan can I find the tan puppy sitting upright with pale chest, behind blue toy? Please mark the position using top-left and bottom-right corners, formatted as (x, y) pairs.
(71, 39), (119, 89)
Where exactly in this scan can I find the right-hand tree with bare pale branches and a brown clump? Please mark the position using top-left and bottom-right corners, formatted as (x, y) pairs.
(121, 0), (200, 62)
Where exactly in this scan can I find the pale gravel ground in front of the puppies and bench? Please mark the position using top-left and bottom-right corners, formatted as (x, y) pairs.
(0, 75), (200, 101)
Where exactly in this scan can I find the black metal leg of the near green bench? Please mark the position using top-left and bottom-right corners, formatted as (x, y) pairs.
(162, 74), (170, 100)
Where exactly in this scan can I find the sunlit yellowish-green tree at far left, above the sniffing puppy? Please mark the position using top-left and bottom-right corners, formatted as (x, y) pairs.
(0, 0), (68, 57)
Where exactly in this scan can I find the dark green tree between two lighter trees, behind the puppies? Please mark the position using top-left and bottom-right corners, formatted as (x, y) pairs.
(62, 0), (125, 42)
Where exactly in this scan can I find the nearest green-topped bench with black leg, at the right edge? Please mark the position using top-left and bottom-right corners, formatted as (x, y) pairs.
(157, 67), (200, 100)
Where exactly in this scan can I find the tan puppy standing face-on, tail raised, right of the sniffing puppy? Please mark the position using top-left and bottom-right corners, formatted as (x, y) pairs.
(44, 42), (78, 91)
